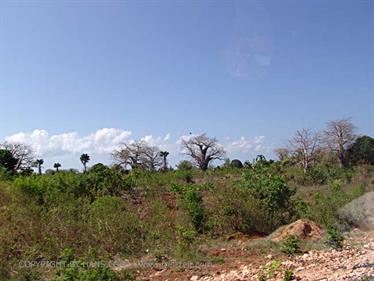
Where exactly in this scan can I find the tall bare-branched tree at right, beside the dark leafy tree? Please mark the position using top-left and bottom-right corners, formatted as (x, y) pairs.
(324, 119), (356, 167)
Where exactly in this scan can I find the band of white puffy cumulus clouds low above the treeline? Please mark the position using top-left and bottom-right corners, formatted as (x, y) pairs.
(0, 128), (268, 167)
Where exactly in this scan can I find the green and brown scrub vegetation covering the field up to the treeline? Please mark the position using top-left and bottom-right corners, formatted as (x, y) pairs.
(0, 119), (374, 281)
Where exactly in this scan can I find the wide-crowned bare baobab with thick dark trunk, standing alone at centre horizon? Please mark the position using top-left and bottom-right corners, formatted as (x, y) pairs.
(182, 134), (225, 171)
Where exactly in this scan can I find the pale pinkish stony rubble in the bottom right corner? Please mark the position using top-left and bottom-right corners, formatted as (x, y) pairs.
(190, 230), (374, 281)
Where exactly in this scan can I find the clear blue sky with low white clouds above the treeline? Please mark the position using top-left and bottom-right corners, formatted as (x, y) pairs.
(0, 0), (374, 167)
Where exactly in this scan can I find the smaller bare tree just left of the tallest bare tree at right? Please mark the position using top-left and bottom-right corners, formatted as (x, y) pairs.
(290, 129), (319, 173)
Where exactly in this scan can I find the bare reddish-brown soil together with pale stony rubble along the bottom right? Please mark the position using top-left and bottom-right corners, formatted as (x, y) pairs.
(133, 229), (374, 281)
